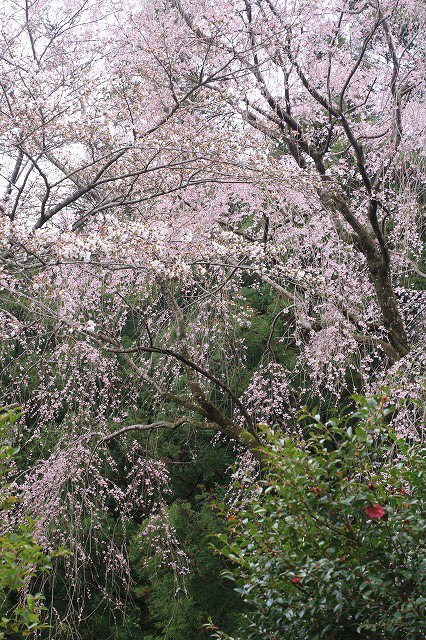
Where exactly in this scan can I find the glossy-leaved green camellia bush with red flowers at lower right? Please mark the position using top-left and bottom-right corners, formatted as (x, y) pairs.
(212, 397), (426, 640)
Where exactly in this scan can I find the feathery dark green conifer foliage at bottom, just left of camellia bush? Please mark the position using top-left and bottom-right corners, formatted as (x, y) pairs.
(128, 496), (242, 640)
